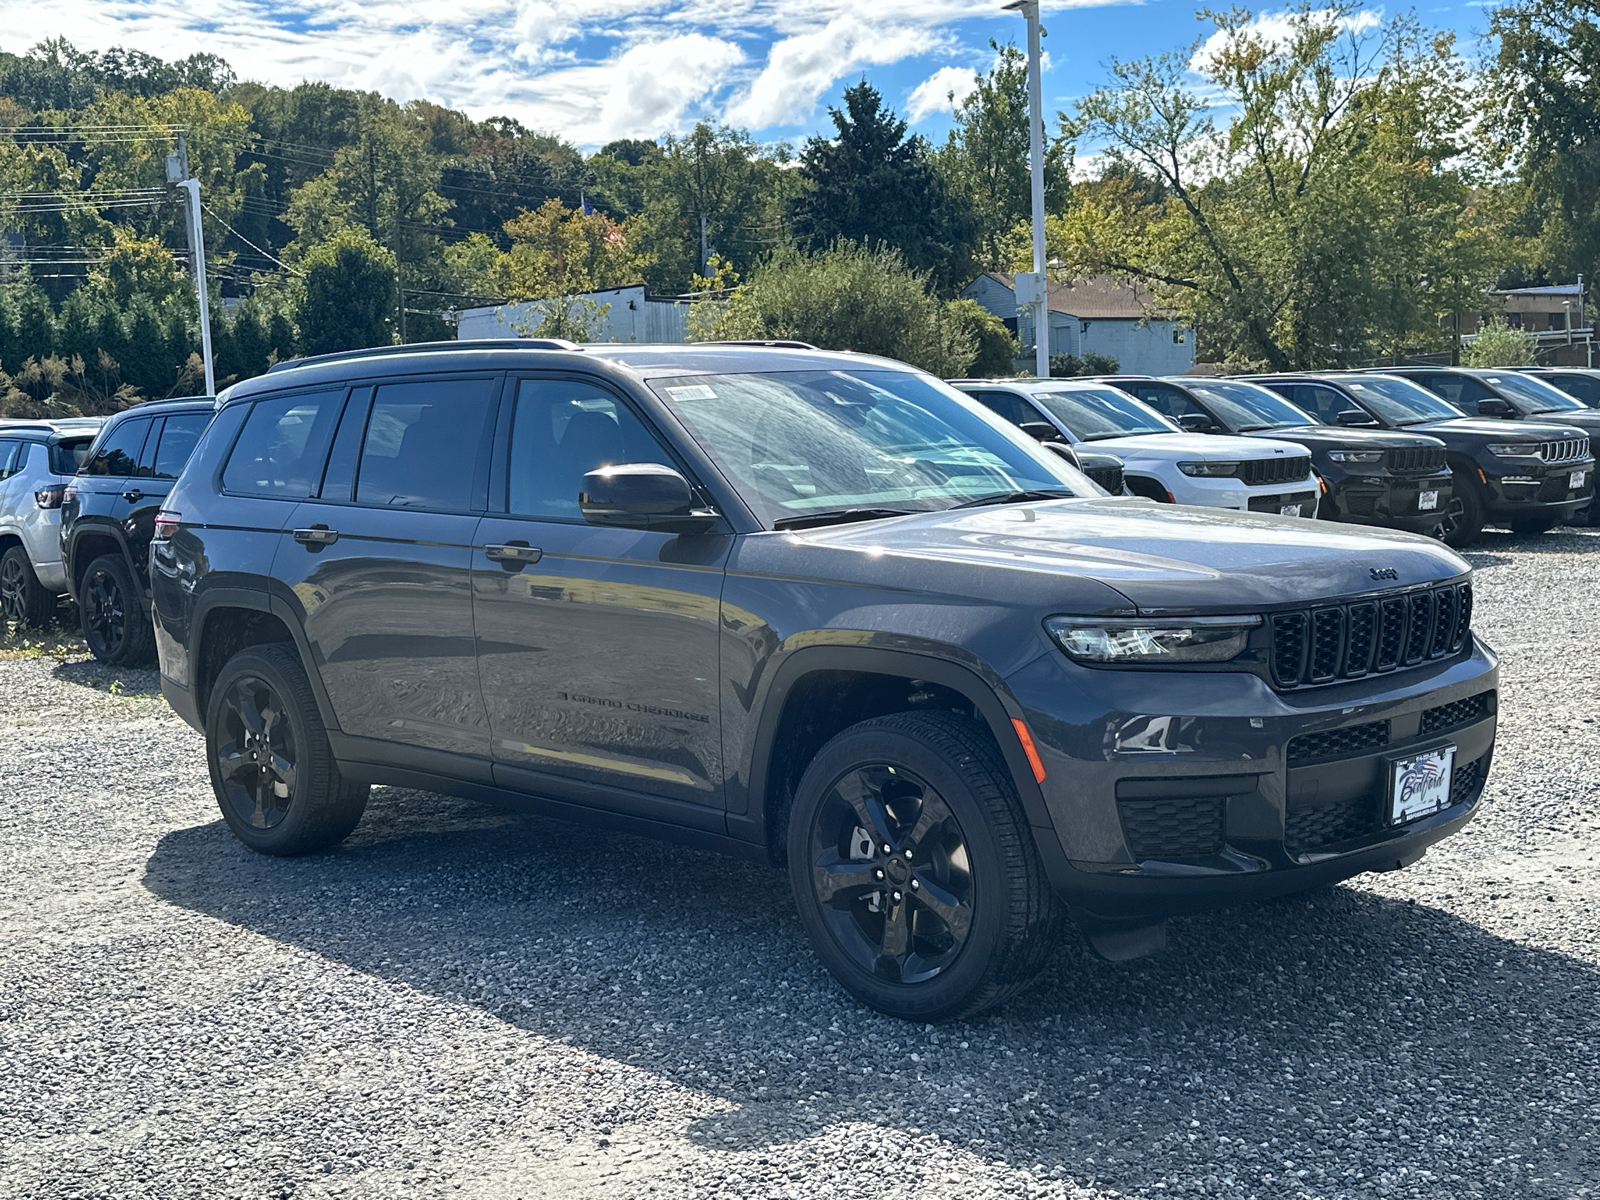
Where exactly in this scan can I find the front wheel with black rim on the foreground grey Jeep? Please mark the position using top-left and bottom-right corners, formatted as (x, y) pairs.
(789, 712), (1066, 1021)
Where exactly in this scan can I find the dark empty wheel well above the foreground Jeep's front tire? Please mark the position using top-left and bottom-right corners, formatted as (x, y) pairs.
(763, 670), (992, 867)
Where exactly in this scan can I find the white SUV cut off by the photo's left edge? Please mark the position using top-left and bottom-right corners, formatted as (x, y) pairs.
(0, 416), (101, 626)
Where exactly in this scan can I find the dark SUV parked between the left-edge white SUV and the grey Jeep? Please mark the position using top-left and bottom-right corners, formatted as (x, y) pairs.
(61, 397), (216, 666)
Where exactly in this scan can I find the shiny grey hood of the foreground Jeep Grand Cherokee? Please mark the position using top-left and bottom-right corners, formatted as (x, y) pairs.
(794, 496), (1469, 614)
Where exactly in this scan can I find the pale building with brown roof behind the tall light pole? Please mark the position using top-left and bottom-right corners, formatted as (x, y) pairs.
(962, 270), (1195, 374)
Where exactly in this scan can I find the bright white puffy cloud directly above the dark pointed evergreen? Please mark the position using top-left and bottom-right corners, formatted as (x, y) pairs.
(726, 16), (934, 130)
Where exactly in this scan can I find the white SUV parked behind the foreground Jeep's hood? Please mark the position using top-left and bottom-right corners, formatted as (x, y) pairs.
(950, 379), (1320, 517)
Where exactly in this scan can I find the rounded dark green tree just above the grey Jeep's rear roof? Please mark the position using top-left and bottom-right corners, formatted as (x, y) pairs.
(294, 227), (398, 354)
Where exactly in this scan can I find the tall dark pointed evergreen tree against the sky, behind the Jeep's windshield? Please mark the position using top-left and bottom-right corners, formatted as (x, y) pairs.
(790, 80), (974, 288)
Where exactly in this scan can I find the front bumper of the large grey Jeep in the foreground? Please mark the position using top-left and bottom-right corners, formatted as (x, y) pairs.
(1006, 642), (1499, 923)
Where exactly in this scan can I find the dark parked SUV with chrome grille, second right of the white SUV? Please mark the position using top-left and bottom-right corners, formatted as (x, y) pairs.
(1258, 373), (1595, 546)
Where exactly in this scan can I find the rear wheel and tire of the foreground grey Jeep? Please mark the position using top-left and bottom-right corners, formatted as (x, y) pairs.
(205, 645), (370, 854)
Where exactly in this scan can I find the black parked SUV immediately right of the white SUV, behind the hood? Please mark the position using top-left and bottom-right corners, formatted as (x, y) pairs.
(1106, 376), (1451, 534)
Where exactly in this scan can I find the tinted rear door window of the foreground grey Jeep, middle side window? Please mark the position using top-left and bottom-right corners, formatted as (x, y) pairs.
(355, 379), (498, 512)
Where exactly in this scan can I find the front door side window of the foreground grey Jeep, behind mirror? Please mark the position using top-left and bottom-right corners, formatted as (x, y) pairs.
(507, 379), (675, 518)
